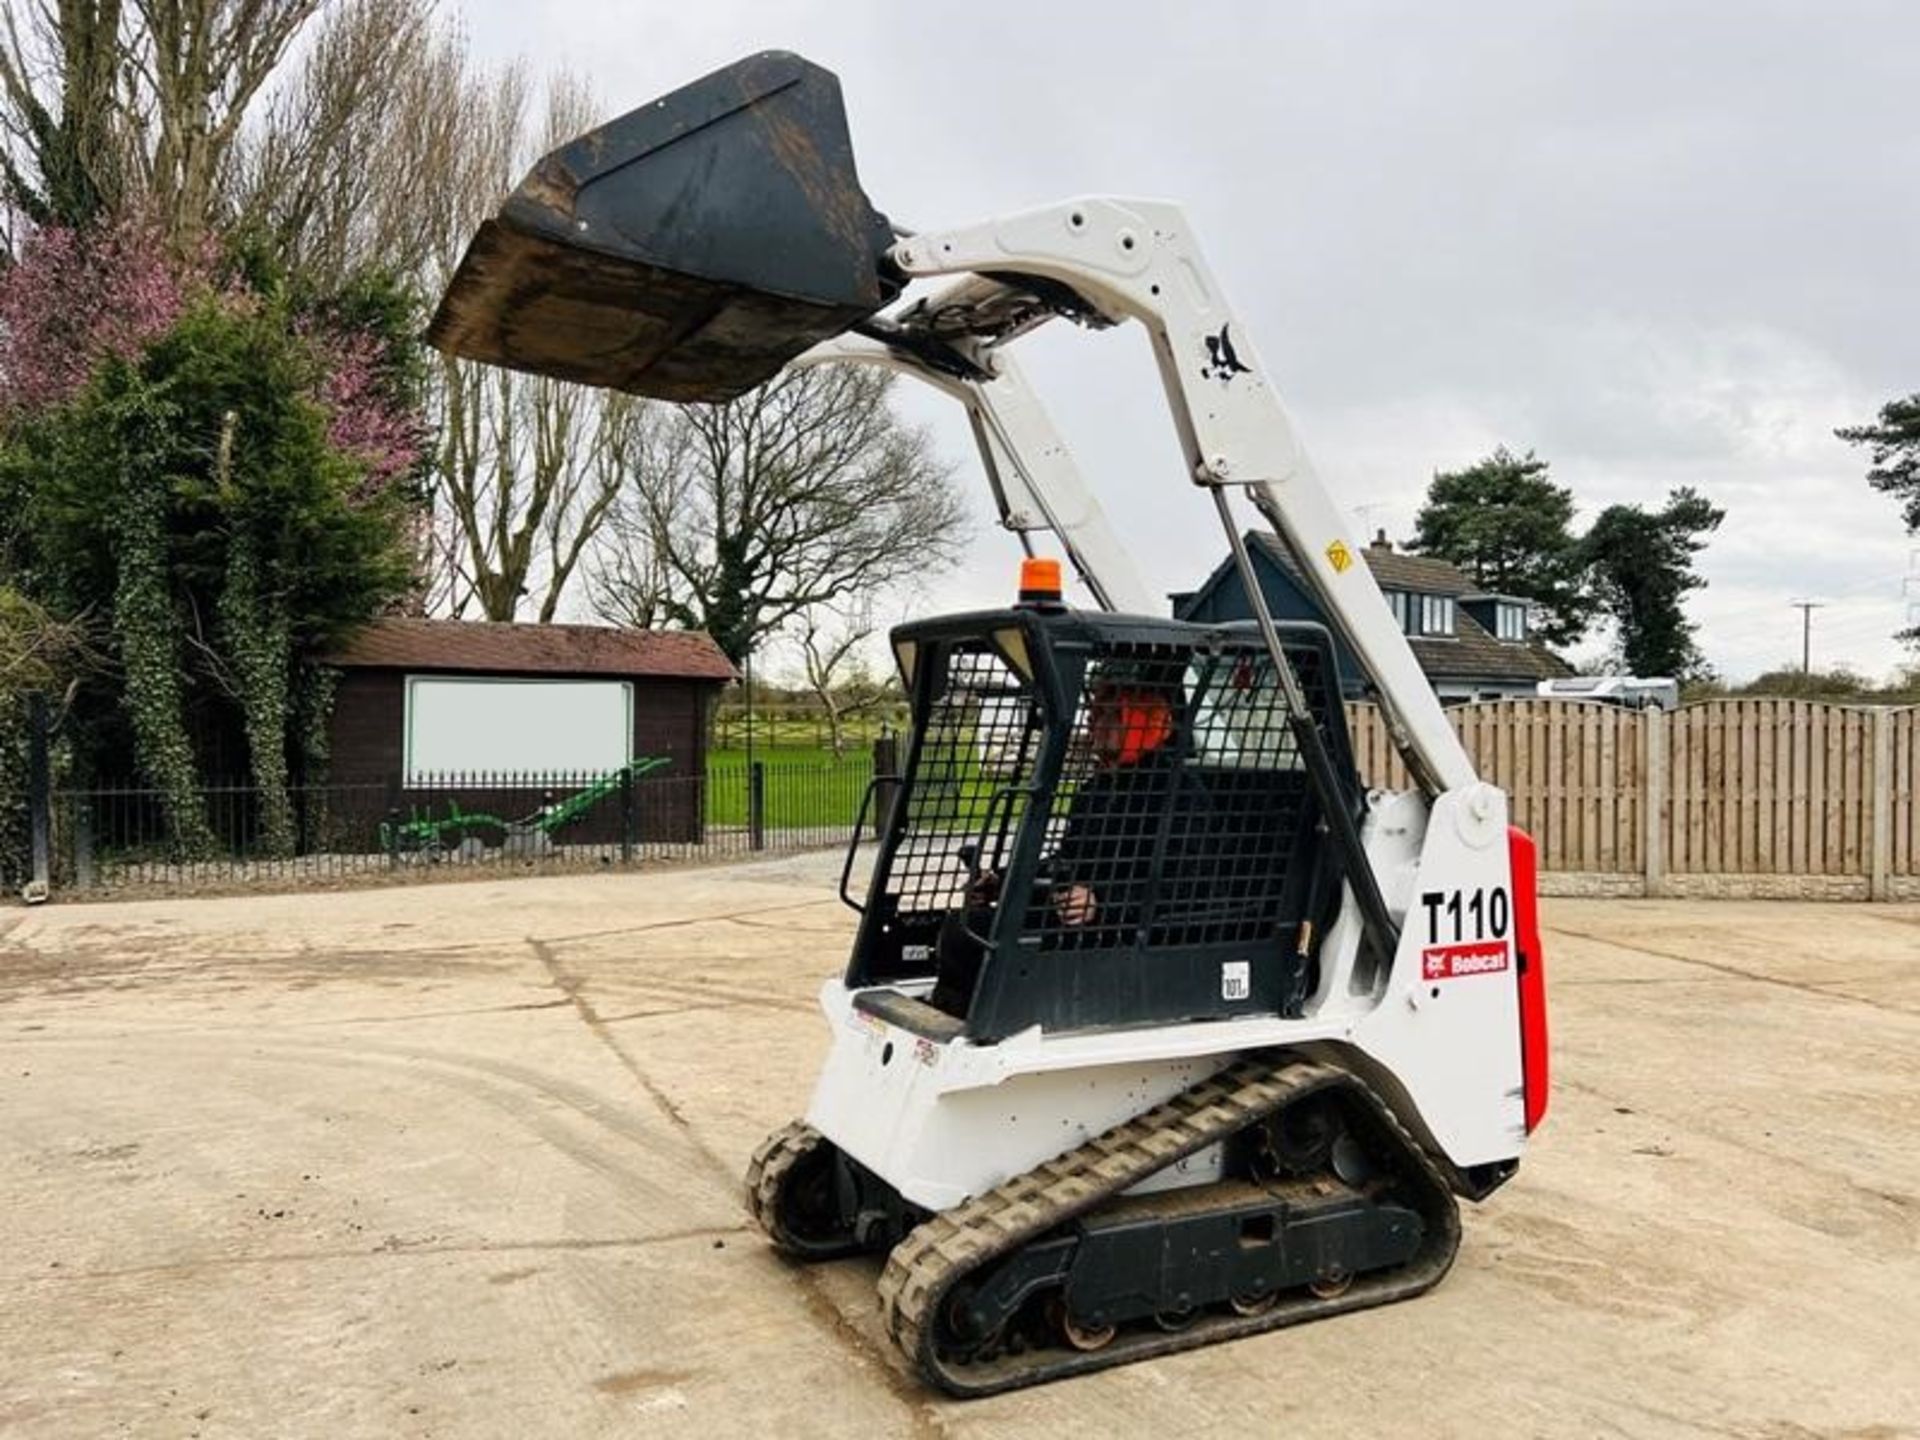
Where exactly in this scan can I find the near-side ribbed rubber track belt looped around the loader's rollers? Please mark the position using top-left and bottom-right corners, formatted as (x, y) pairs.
(879, 1058), (1459, 1396)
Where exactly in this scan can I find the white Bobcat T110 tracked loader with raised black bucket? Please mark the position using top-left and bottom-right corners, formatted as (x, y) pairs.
(432, 52), (1548, 1396)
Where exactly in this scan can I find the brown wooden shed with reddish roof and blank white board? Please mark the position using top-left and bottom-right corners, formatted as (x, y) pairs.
(326, 618), (733, 843)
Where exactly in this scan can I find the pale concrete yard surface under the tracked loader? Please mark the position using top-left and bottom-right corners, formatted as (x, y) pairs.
(0, 856), (1920, 1440)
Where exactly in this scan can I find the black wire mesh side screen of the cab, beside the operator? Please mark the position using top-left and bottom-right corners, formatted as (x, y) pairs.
(1023, 645), (1329, 948)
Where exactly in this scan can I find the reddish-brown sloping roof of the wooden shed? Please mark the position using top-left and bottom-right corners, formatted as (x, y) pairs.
(326, 618), (733, 682)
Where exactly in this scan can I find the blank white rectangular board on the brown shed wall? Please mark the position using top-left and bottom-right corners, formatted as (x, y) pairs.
(407, 676), (634, 785)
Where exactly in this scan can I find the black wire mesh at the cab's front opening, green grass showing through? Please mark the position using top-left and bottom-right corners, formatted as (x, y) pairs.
(887, 643), (1043, 916)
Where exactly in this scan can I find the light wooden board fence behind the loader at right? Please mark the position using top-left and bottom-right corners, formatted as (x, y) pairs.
(1348, 699), (1920, 899)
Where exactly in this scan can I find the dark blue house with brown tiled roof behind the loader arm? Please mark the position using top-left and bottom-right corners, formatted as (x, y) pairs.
(1173, 532), (1572, 701)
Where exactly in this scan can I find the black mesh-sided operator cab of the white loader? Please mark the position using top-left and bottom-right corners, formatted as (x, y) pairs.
(847, 587), (1361, 1043)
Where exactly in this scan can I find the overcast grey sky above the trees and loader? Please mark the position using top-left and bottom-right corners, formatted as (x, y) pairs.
(463, 0), (1920, 676)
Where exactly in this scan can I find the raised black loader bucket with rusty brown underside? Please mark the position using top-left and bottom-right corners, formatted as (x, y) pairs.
(426, 50), (899, 401)
